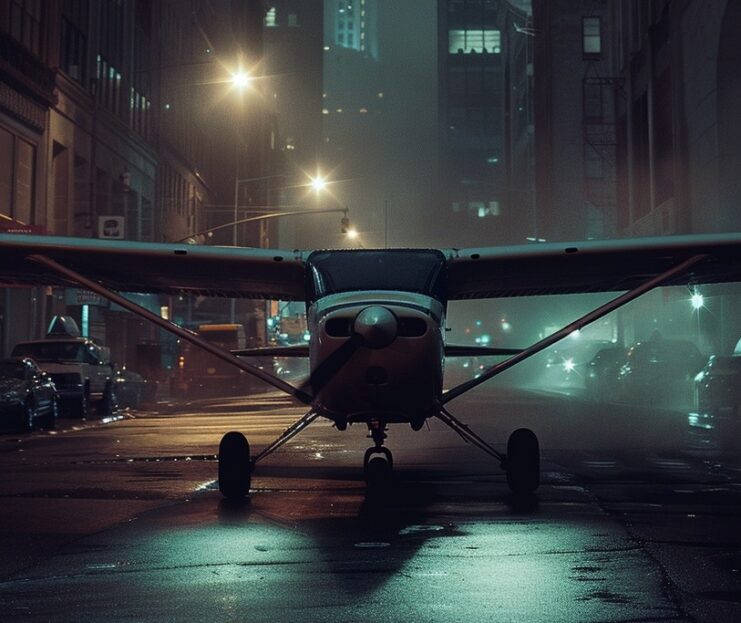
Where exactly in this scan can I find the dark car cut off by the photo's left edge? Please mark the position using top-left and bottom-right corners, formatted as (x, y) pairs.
(0, 357), (58, 431)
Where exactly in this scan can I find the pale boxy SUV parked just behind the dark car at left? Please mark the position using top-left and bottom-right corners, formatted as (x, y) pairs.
(11, 337), (116, 418)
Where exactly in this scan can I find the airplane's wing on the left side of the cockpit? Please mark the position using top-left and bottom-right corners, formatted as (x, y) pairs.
(0, 234), (305, 301)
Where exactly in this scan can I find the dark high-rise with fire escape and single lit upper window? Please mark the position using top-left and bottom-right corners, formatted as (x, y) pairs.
(532, 0), (621, 240)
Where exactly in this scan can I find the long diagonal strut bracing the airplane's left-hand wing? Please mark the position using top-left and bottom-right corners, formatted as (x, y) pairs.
(26, 255), (311, 405)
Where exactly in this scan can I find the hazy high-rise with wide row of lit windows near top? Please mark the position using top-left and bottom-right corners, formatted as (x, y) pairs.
(436, 0), (537, 245)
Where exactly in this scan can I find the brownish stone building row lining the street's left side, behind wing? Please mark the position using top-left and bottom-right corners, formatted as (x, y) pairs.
(0, 0), (267, 364)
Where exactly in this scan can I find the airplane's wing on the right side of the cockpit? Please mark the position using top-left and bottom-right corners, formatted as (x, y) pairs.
(448, 234), (741, 300)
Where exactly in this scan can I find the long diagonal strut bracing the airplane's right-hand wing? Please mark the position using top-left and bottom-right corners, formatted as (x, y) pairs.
(442, 255), (710, 404)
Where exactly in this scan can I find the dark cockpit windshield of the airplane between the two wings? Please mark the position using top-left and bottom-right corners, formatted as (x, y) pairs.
(307, 249), (445, 303)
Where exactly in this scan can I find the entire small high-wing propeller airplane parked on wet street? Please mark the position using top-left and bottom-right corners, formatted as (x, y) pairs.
(0, 233), (741, 498)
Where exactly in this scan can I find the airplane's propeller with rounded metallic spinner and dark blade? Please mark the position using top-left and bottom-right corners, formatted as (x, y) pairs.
(301, 305), (399, 396)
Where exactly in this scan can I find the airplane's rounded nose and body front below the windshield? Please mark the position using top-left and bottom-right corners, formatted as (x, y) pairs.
(308, 291), (445, 428)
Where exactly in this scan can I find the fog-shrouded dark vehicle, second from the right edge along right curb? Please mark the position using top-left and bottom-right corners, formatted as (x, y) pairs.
(620, 337), (705, 407)
